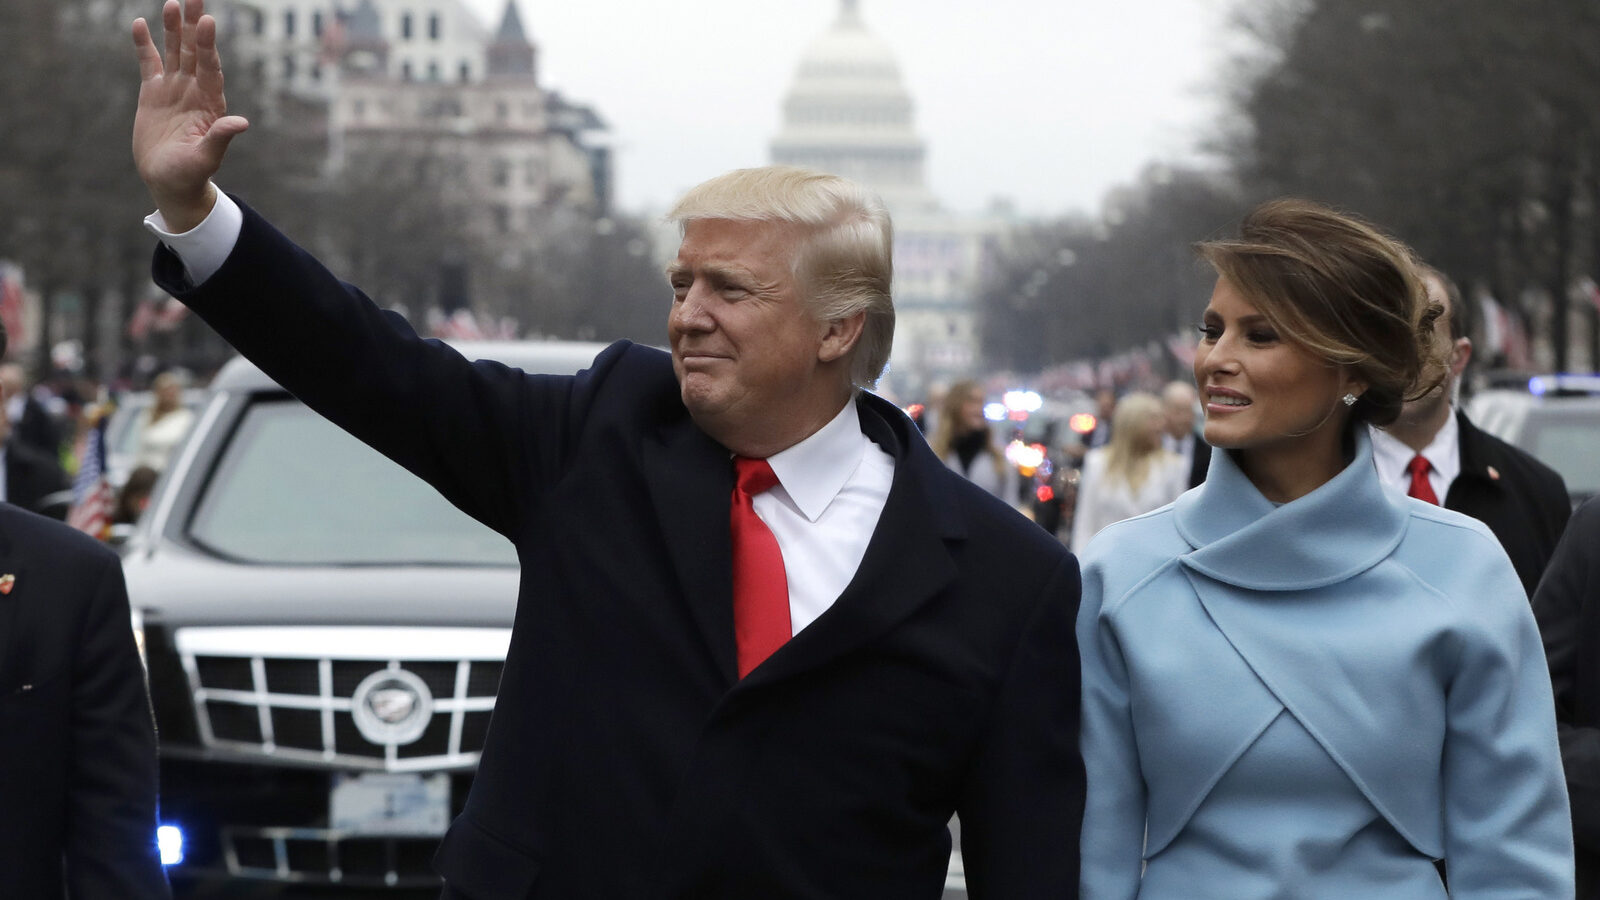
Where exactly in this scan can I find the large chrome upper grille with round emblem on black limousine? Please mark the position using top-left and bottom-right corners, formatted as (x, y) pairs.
(173, 628), (510, 772)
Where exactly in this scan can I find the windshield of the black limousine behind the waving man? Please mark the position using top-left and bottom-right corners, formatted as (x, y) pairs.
(189, 399), (517, 565)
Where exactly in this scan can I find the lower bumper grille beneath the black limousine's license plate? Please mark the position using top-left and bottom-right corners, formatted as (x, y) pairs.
(222, 828), (438, 887)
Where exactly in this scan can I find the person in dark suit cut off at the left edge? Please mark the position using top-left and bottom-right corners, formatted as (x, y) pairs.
(0, 325), (171, 900)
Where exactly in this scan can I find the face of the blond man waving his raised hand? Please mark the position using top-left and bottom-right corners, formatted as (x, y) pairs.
(667, 219), (848, 450)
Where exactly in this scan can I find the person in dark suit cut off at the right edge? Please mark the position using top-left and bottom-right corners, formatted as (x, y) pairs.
(1533, 496), (1600, 900)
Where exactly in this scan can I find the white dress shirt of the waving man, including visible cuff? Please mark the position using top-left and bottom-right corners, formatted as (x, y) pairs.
(144, 191), (894, 634)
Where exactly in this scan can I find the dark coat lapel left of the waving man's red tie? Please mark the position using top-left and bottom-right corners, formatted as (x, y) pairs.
(642, 416), (738, 684)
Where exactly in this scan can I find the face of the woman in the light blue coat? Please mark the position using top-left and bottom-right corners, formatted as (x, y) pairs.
(1195, 279), (1362, 455)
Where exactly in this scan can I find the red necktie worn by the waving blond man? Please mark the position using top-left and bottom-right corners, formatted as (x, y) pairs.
(728, 456), (790, 677)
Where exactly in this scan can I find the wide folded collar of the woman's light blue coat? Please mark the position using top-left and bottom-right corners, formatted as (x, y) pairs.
(1174, 429), (1408, 591)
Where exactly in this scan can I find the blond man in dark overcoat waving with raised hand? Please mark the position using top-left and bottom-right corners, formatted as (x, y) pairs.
(134, 0), (1083, 900)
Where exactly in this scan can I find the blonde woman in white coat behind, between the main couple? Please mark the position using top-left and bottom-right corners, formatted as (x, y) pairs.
(1072, 392), (1189, 549)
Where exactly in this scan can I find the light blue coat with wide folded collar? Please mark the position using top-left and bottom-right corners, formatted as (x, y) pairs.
(1078, 434), (1573, 900)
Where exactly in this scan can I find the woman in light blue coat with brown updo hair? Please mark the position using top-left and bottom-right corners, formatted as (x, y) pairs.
(1078, 200), (1573, 900)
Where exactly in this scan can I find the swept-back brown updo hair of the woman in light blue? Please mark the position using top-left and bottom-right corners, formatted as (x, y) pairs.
(1195, 199), (1443, 426)
